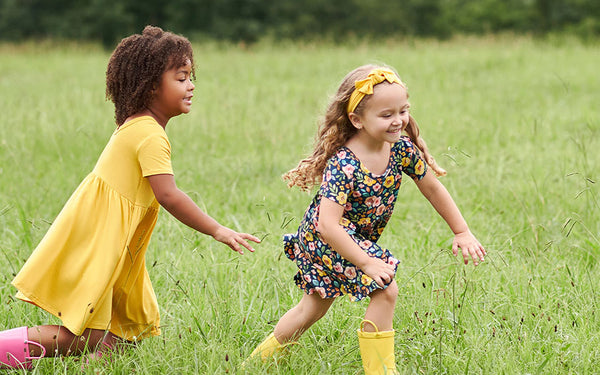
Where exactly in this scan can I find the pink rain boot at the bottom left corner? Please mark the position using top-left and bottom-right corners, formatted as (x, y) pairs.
(0, 327), (46, 370)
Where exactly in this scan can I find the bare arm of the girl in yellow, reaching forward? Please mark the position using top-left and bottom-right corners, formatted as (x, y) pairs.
(147, 174), (260, 254)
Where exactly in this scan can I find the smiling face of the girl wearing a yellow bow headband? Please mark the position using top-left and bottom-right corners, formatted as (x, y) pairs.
(348, 82), (410, 145)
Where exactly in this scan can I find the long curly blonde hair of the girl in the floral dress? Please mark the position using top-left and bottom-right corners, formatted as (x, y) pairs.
(283, 64), (446, 191)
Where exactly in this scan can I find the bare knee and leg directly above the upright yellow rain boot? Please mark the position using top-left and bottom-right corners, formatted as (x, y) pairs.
(365, 280), (398, 332)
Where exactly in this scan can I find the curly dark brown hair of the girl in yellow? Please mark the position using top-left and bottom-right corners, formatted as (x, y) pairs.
(106, 26), (195, 126)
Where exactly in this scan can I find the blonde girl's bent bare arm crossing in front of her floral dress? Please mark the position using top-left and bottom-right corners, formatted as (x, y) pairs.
(318, 197), (394, 286)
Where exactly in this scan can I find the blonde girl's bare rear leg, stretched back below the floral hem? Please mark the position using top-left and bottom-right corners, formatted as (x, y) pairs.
(274, 293), (335, 344)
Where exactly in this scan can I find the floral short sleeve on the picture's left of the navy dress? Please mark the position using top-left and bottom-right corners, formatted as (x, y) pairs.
(319, 149), (357, 206)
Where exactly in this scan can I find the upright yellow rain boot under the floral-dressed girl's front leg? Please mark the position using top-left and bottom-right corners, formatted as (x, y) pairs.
(357, 320), (397, 375)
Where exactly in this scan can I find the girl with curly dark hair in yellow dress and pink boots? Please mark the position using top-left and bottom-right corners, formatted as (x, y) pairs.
(0, 26), (259, 368)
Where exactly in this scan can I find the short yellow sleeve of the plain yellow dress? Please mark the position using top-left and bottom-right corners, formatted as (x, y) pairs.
(138, 134), (173, 177)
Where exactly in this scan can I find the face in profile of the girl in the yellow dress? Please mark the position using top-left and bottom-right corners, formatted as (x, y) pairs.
(149, 60), (195, 126)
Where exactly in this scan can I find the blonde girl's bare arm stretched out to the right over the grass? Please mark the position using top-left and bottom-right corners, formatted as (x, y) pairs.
(416, 172), (486, 265)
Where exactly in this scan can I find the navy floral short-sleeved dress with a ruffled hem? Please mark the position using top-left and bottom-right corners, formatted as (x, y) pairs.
(283, 136), (426, 300)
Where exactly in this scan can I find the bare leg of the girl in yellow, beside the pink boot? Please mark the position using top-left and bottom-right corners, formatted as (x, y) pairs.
(27, 325), (122, 357)
